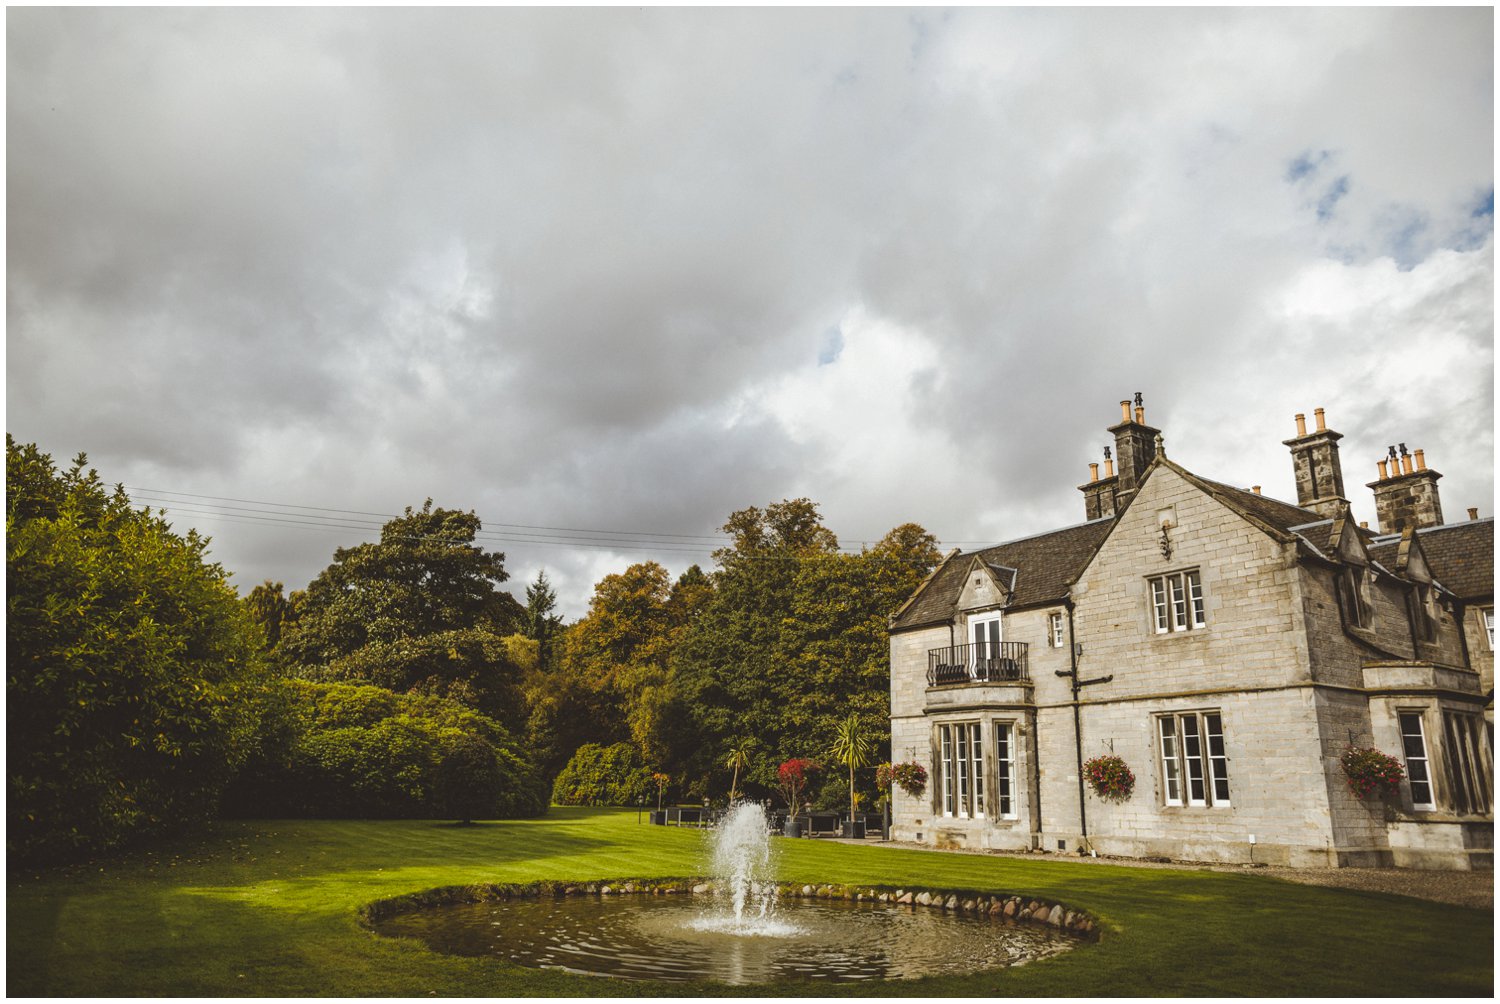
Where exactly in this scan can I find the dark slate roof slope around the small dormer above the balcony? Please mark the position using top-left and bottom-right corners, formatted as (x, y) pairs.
(891, 516), (1115, 632)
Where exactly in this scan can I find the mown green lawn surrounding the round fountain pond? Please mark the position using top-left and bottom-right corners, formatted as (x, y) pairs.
(6, 809), (1494, 996)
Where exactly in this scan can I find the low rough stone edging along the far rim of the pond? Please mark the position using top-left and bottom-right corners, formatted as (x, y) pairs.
(359, 878), (1101, 941)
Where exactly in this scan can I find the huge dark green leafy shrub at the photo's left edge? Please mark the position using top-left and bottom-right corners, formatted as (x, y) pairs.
(6, 437), (263, 857)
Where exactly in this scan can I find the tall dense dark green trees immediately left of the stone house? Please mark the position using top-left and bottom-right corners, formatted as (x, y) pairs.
(669, 498), (939, 804)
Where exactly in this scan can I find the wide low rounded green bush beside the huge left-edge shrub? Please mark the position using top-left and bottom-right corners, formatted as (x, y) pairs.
(225, 680), (546, 819)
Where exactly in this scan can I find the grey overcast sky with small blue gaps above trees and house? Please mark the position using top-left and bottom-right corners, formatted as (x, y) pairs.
(6, 8), (1494, 617)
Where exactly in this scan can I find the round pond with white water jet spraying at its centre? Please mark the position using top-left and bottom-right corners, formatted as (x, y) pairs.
(372, 803), (1082, 984)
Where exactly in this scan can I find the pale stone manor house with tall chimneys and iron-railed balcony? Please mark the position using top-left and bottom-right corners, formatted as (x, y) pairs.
(890, 395), (1494, 869)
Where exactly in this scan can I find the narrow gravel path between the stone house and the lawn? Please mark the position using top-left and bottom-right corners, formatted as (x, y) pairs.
(843, 840), (1496, 909)
